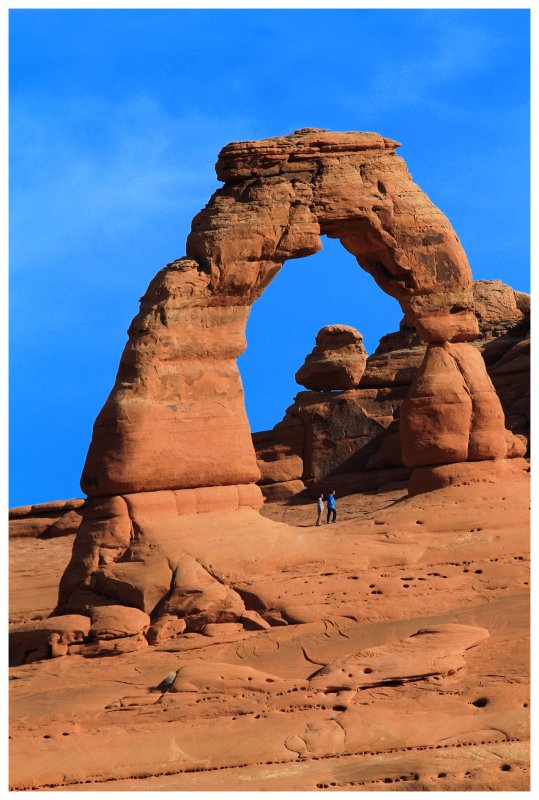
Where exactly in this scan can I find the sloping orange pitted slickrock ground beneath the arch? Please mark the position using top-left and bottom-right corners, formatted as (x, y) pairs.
(10, 478), (530, 792)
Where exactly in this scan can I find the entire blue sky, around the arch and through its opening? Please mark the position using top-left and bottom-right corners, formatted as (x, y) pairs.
(9, 9), (529, 505)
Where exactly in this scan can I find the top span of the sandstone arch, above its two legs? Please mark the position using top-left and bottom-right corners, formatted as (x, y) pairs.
(187, 128), (478, 342)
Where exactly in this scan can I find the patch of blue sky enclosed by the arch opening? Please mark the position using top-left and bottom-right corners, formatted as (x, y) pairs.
(238, 235), (402, 433)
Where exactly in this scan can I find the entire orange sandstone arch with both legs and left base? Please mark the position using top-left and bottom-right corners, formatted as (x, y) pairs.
(54, 129), (521, 628)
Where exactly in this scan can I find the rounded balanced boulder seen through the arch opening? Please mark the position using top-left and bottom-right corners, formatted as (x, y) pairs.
(296, 325), (367, 391)
